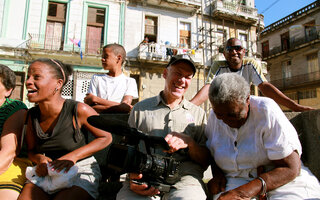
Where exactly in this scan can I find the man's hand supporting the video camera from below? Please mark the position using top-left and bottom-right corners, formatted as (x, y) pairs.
(129, 173), (160, 196)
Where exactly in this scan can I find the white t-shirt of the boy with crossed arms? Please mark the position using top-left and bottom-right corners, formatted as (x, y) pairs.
(88, 74), (138, 103)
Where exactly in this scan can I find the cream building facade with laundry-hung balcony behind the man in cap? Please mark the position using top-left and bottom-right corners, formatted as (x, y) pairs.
(124, 0), (264, 110)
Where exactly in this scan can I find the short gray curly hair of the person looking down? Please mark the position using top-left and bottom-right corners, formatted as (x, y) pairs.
(209, 73), (250, 105)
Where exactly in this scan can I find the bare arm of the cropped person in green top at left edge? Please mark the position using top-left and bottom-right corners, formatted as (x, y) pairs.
(0, 109), (27, 174)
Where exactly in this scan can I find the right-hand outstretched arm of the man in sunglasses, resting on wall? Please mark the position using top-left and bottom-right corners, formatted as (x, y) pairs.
(258, 81), (314, 112)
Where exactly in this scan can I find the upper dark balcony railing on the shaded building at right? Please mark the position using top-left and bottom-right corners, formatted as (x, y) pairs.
(262, 31), (320, 58)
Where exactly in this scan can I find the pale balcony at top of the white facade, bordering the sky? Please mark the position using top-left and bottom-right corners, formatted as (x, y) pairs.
(212, 0), (258, 18)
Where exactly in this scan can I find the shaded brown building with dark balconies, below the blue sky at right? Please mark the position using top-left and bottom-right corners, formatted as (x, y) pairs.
(259, 1), (320, 110)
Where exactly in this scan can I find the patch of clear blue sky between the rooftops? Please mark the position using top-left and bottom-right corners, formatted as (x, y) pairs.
(255, 0), (316, 27)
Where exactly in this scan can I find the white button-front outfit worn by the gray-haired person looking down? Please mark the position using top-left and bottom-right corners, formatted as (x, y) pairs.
(205, 96), (320, 199)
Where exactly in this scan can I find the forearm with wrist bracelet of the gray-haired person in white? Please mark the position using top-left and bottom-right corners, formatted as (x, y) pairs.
(218, 151), (301, 200)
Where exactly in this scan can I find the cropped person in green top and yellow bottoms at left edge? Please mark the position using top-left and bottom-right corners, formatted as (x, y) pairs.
(0, 65), (31, 199)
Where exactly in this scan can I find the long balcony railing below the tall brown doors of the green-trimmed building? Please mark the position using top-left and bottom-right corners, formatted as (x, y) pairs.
(29, 34), (103, 55)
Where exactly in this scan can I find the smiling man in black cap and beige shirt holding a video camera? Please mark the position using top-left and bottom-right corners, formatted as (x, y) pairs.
(117, 55), (210, 200)
